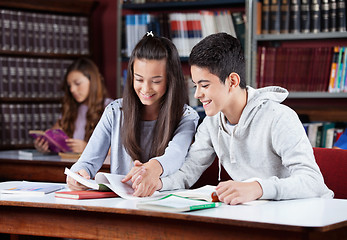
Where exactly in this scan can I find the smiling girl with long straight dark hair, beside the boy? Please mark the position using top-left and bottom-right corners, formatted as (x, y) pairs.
(67, 33), (199, 196)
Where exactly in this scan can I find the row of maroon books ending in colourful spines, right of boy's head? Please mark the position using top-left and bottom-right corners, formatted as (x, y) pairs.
(256, 46), (347, 92)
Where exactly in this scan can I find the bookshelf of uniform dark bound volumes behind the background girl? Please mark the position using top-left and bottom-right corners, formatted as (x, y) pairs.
(0, 0), (96, 149)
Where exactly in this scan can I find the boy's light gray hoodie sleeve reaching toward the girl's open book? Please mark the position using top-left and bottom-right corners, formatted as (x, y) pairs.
(161, 117), (216, 191)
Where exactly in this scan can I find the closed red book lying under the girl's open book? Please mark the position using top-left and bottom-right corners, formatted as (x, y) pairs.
(55, 190), (118, 200)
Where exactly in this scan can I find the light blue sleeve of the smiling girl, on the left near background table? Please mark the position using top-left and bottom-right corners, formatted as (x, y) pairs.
(71, 103), (115, 178)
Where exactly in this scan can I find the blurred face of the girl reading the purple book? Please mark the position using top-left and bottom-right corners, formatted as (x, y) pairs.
(67, 70), (90, 103)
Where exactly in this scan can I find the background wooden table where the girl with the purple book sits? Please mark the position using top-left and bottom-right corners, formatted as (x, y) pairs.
(0, 150), (110, 183)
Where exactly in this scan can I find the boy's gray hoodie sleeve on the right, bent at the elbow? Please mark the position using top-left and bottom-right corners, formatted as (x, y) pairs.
(258, 110), (333, 200)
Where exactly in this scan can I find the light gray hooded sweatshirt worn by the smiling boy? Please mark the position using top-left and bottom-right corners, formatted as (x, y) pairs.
(162, 86), (334, 200)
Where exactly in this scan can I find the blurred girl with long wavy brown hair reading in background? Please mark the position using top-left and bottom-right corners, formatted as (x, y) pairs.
(34, 58), (112, 153)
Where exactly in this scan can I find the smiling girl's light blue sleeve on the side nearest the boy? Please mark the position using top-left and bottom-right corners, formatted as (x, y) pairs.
(153, 105), (199, 177)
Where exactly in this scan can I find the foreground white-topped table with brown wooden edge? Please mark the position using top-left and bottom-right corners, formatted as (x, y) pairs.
(0, 183), (347, 240)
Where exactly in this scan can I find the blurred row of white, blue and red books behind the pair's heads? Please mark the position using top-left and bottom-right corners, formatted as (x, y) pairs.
(123, 10), (245, 57)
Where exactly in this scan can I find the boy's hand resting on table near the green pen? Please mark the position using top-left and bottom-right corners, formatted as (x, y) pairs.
(216, 180), (263, 205)
